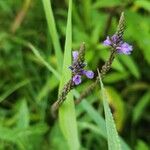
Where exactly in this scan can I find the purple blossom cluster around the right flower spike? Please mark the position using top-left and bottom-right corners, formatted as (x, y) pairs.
(103, 34), (133, 55)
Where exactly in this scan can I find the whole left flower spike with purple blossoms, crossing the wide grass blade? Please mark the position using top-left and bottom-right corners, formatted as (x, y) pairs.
(51, 43), (94, 116)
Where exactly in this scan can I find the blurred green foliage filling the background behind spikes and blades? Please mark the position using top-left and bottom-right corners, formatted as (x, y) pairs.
(0, 0), (150, 150)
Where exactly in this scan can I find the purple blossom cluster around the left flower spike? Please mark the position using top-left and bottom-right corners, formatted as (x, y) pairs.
(69, 51), (94, 85)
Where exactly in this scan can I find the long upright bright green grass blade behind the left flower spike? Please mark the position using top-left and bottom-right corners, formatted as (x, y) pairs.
(59, 0), (80, 150)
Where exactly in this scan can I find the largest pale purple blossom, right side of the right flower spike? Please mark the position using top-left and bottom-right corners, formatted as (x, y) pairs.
(116, 42), (133, 55)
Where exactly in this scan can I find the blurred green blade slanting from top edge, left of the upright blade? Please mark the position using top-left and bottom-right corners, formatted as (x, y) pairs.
(42, 0), (63, 71)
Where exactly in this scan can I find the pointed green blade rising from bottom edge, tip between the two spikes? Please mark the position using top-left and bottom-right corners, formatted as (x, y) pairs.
(98, 72), (121, 150)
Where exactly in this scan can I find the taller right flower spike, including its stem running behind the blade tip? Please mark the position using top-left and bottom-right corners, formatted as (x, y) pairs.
(76, 12), (133, 104)
